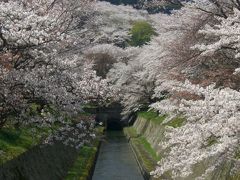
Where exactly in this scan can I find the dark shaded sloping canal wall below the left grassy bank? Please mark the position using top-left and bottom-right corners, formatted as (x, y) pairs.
(0, 143), (77, 180)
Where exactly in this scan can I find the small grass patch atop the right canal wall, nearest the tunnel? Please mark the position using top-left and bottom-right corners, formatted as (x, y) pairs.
(138, 110), (167, 124)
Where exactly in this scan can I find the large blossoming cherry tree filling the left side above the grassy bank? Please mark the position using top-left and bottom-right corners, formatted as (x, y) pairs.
(0, 0), (115, 131)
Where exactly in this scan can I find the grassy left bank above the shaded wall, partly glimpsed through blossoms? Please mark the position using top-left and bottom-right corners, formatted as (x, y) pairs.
(0, 113), (95, 164)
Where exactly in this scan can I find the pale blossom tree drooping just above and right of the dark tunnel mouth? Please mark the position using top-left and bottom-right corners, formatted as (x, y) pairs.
(108, 45), (153, 115)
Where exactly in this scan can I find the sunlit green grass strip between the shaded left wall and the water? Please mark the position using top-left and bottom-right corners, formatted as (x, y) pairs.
(65, 146), (97, 180)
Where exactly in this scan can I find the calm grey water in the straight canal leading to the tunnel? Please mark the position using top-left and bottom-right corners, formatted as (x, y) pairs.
(93, 131), (143, 180)
